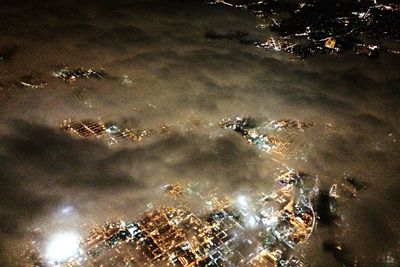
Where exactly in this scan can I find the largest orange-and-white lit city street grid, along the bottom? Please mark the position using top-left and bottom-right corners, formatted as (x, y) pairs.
(28, 171), (315, 266)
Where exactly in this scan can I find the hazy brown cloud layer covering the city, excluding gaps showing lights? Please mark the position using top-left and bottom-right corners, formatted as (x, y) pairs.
(0, 0), (400, 266)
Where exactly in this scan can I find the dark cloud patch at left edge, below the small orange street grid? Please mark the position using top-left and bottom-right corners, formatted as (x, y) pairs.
(1, 122), (134, 188)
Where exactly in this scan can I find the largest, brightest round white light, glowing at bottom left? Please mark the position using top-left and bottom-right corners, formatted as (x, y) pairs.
(46, 233), (79, 263)
